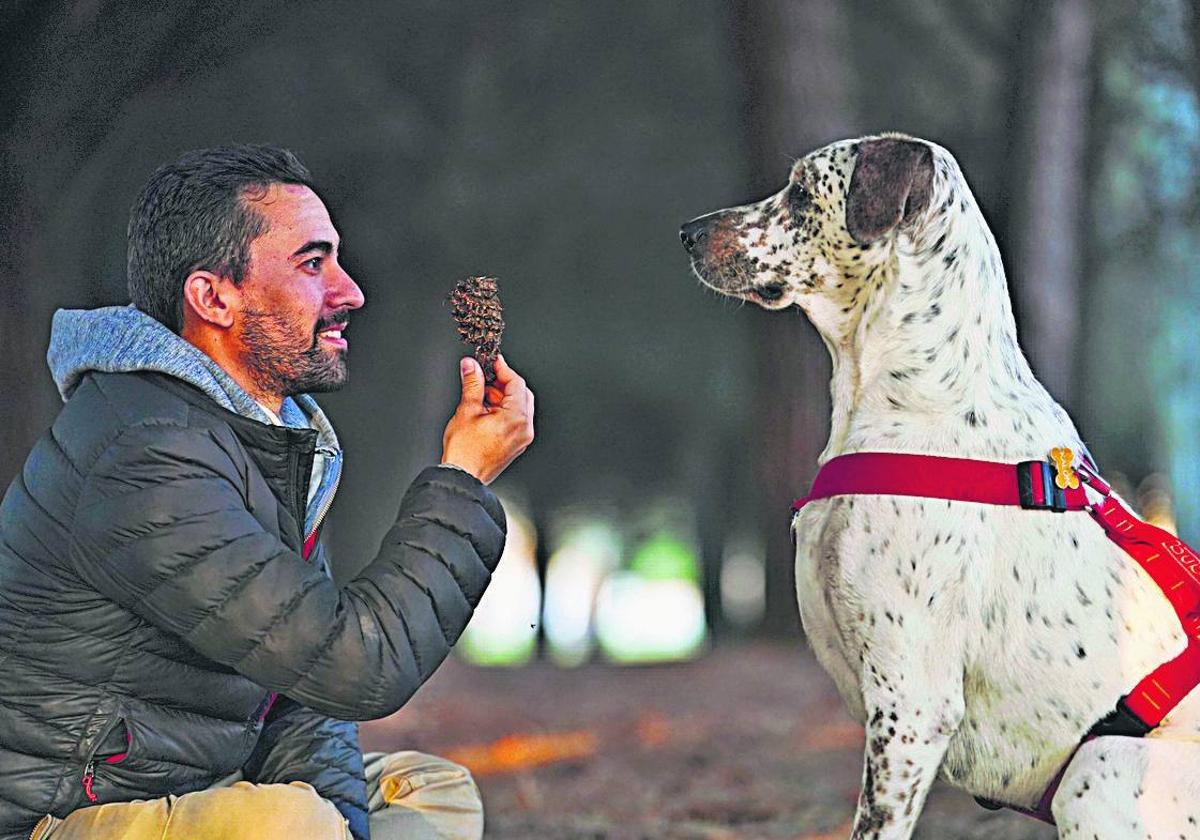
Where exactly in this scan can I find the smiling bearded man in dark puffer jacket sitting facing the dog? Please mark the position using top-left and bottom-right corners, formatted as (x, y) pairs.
(0, 146), (534, 840)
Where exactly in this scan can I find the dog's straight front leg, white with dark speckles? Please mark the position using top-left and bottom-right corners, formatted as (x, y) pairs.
(852, 643), (964, 840)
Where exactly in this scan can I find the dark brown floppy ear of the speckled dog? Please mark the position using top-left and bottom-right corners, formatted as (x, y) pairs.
(846, 137), (934, 245)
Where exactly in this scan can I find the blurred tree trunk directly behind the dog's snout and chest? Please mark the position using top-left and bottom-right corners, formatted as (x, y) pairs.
(733, 0), (851, 635)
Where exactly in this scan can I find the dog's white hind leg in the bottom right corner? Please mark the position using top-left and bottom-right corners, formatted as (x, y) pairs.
(1051, 737), (1200, 840)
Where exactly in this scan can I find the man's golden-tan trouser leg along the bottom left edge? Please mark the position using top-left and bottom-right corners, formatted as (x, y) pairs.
(47, 781), (350, 840)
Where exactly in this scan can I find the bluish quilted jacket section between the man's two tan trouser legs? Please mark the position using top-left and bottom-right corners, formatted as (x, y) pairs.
(242, 697), (370, 840)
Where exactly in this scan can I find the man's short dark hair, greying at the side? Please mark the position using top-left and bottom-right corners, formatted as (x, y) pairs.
(127, 145), (313, 332)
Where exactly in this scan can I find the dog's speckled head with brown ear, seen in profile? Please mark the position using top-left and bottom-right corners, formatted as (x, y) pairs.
(680, 134), (937, 331)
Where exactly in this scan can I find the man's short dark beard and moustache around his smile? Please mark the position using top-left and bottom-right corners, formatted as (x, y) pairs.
(241, 310), (349, 397)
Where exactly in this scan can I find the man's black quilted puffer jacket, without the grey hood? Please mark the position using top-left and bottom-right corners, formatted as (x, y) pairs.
(0, 373), (505, 839)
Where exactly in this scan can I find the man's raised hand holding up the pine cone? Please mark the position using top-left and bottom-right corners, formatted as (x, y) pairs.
(442, 355), (533, 484)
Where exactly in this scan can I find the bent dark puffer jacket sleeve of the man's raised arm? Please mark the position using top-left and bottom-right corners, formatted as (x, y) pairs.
(71, 425), (505, 720)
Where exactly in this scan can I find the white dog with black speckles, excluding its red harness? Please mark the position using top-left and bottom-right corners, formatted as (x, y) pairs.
(682, 134), (1200, 840)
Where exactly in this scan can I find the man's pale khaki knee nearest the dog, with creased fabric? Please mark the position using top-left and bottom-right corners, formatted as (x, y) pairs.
(367, 750), (484, 840)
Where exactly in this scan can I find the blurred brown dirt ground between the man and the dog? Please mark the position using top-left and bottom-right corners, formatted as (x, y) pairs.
(362, 643), (1055, 840)
